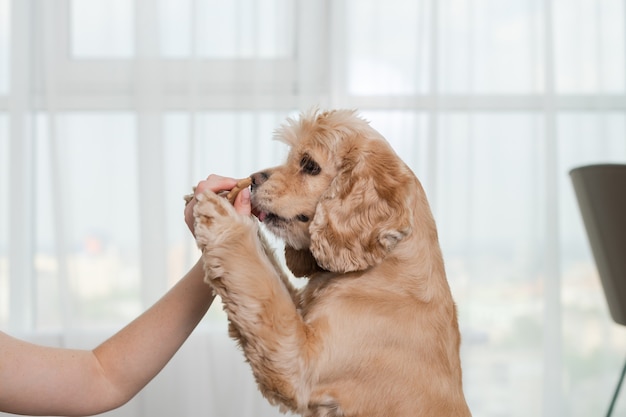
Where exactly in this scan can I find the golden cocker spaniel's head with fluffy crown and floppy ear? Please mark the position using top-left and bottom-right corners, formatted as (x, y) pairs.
(252, 110), (419, 276)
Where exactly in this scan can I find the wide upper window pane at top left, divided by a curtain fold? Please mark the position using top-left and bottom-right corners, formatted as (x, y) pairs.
(71, 0), (294, 59)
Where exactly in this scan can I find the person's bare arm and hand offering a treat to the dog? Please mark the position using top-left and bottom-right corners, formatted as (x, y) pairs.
(0, 176), (250, 416)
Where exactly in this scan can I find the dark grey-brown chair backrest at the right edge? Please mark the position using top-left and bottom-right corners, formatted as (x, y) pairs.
(570, 164), (626, 325)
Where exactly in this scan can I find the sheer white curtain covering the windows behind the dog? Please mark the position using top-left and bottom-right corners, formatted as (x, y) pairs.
(0, 0), (626, 417)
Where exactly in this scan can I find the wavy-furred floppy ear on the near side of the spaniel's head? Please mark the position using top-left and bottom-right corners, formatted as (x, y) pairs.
(309, 140), (417, 273)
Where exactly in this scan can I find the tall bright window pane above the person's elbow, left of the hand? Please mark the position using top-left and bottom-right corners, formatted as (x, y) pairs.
(34, 112), (142, 328)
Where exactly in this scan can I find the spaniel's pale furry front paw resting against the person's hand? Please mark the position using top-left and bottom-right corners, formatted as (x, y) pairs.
(193, 191), (256, 279)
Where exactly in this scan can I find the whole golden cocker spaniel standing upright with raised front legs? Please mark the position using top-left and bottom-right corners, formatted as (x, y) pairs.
(195, 110), (470, 417)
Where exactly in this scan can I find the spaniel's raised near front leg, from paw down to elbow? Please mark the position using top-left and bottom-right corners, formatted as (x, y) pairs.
(194, 192), (312, 410)
